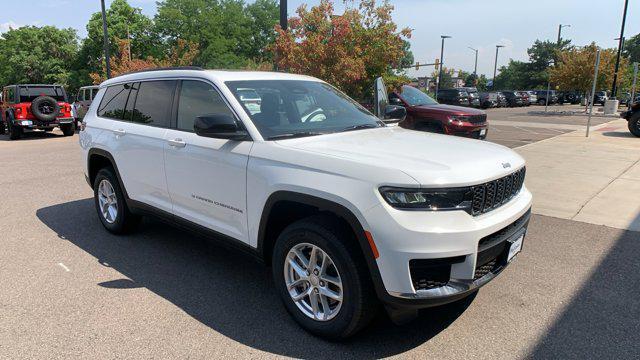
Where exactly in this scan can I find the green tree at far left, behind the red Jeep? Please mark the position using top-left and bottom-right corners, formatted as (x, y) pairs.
(0, 26), (78, 85)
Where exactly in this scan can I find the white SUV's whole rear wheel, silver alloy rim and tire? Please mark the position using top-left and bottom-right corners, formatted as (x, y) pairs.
(93, 166), (140, 234)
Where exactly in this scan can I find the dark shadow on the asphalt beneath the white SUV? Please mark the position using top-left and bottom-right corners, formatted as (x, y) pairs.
(36, 198), (475, 358)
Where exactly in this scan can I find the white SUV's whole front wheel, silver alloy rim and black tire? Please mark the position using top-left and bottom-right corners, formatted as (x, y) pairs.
(272, 215), (379, 340)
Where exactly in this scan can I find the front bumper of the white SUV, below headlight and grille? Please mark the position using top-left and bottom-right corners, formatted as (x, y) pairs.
(367, 187), (531, 308)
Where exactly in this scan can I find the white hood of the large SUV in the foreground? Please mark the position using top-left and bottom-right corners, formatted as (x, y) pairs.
(277, 127), (524, 187)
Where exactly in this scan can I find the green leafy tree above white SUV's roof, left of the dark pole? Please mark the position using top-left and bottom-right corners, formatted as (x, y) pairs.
(155, 0), (279, 68)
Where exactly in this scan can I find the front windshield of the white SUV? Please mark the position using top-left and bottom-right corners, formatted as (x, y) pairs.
(226, 80), (383, 140)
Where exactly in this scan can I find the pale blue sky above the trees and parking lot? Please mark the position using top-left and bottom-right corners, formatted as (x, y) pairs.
(0, 0), (640, 77)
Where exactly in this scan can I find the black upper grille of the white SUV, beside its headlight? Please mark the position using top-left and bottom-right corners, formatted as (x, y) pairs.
(471, 167), (526, 215)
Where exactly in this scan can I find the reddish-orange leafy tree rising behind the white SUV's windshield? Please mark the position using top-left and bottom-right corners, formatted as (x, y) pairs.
(273, 0), (411, 99)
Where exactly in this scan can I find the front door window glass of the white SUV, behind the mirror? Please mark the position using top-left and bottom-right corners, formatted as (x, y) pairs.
(177, 80), (234, 131)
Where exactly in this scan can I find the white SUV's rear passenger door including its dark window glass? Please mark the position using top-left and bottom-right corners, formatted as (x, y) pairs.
(98, 80), (176, 212)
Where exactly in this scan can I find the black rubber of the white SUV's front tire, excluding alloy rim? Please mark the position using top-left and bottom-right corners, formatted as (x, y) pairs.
(272, 224), (362, 339)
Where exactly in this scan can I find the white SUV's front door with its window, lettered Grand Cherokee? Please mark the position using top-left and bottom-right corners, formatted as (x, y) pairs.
(164, 80), (253, 242)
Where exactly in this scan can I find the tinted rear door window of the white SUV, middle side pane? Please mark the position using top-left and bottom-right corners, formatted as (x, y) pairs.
(131, 80), (176, 127)
